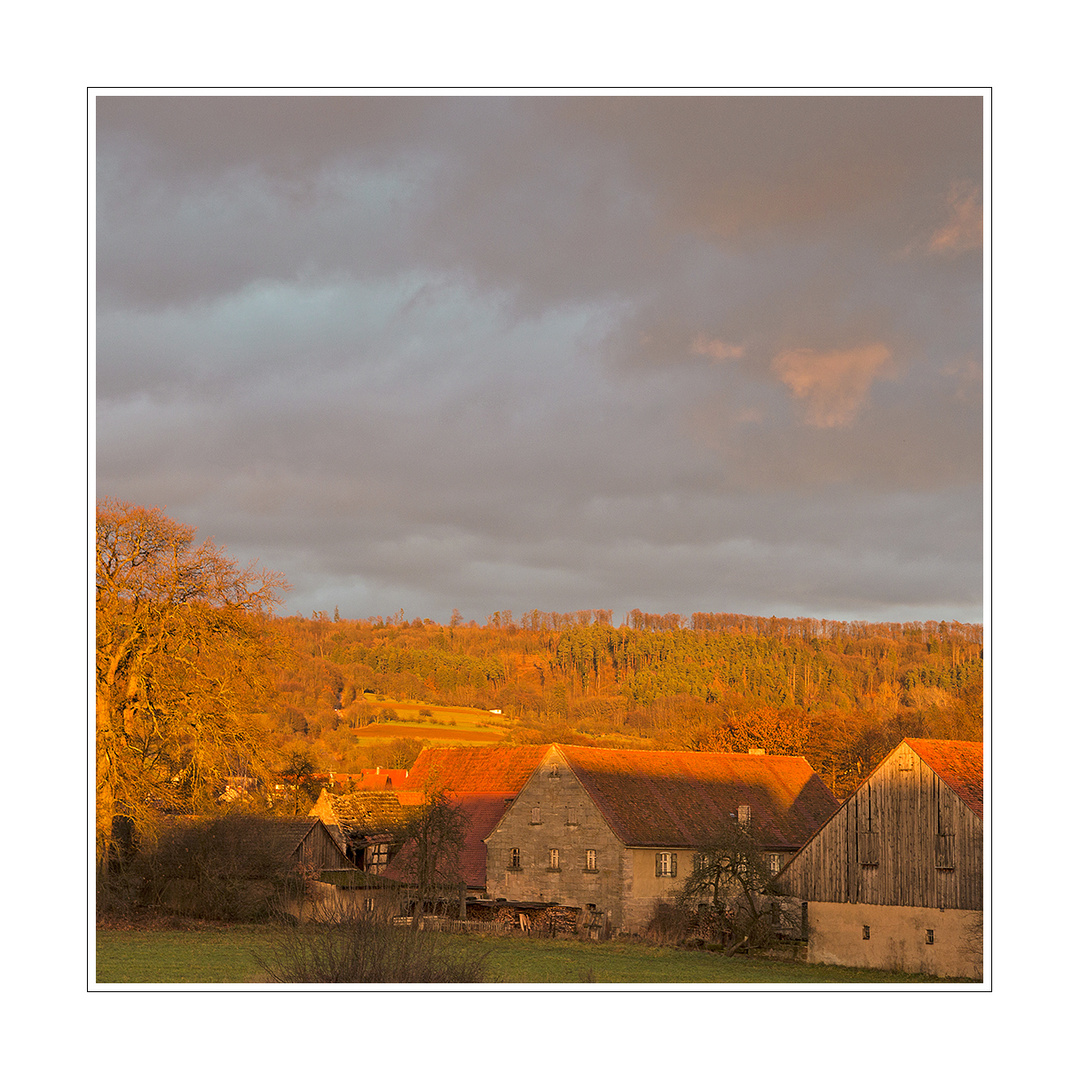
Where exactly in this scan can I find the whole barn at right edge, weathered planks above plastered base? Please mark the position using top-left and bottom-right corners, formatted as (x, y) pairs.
(775, 739), (983, 978)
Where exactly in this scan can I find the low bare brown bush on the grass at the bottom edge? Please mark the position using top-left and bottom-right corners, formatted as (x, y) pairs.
(255, 913), (487, 983)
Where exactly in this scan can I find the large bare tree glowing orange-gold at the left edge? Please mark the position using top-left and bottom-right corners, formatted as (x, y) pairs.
(96, 500), (287, 870)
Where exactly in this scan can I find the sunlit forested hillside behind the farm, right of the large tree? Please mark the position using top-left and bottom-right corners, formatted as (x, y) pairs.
(272, 610), (983, 795)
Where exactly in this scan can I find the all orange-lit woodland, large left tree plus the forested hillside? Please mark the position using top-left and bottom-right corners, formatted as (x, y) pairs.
(96, 500), (983, 864)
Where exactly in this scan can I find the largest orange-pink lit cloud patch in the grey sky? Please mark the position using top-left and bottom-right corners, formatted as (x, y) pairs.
(772, 341), (892, 428)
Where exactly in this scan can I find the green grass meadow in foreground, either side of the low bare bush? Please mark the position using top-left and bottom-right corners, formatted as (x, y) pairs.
(96, 927), (957, 985)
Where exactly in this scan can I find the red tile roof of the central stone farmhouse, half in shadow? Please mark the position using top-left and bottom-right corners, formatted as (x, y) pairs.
(556, 746), (840, 850)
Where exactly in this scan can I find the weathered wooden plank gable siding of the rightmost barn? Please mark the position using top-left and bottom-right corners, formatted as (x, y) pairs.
(778, 744), (983, 910)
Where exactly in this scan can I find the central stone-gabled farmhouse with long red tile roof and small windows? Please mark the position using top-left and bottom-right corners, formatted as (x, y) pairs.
(486, 745), (838, 932)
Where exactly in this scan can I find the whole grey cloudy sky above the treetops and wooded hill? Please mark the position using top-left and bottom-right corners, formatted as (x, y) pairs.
(96, 96), (983, 622)
